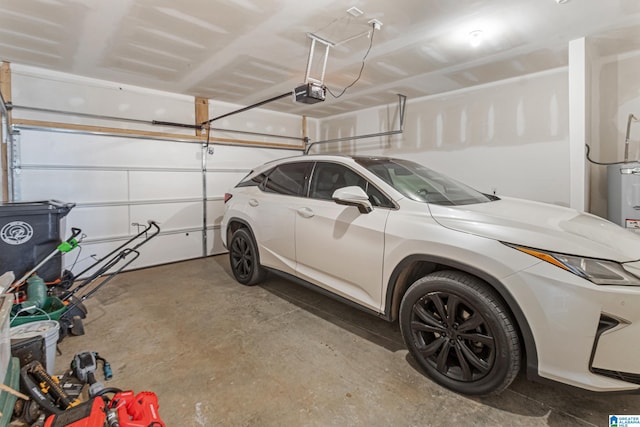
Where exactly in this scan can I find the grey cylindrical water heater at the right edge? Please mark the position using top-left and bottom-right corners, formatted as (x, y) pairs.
(607, 163), (640, 233)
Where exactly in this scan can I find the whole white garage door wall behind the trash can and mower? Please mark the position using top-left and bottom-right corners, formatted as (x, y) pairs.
(6, 64), (302, 273)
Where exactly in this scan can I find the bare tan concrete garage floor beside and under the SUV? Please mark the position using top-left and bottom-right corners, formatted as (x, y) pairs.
(51, 255), (640, 427)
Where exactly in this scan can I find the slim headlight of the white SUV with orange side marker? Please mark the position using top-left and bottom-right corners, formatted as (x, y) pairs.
(507, 244), (640, 286)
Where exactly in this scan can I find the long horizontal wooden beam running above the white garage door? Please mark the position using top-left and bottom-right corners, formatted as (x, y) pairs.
(13, 119), (304, 150)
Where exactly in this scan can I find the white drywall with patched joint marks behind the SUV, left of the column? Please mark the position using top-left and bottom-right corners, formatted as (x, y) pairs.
(313, 68), (570, 206)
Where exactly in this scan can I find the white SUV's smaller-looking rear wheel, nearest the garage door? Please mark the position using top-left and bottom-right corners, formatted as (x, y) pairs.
(229, 228), (265, 286)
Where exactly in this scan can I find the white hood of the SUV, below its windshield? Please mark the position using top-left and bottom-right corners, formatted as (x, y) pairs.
(429, 198), (640, 262)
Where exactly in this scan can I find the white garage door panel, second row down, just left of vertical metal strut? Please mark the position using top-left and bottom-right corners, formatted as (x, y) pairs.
(129, 171), (202, 200)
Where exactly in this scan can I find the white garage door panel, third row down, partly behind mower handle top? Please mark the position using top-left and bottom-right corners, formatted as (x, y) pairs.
(131, 201), (202, 233)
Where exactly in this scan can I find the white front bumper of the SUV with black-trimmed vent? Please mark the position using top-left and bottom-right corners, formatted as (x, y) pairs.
(503, 262), (640, 391)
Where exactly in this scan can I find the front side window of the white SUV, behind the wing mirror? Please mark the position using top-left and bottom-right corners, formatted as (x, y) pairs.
(309, 162), (394, 208)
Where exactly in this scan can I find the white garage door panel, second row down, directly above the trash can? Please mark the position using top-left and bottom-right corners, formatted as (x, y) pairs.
(17, 169), (127, 203)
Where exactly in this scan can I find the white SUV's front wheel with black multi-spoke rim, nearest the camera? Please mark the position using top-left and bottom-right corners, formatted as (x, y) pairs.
(399, 271), (521, 395)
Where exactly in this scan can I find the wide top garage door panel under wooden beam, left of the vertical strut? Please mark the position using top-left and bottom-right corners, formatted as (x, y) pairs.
(20, 129), (202, 168)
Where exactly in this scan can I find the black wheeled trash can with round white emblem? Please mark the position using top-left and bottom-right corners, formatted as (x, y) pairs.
(0, 200), (75, 281)
